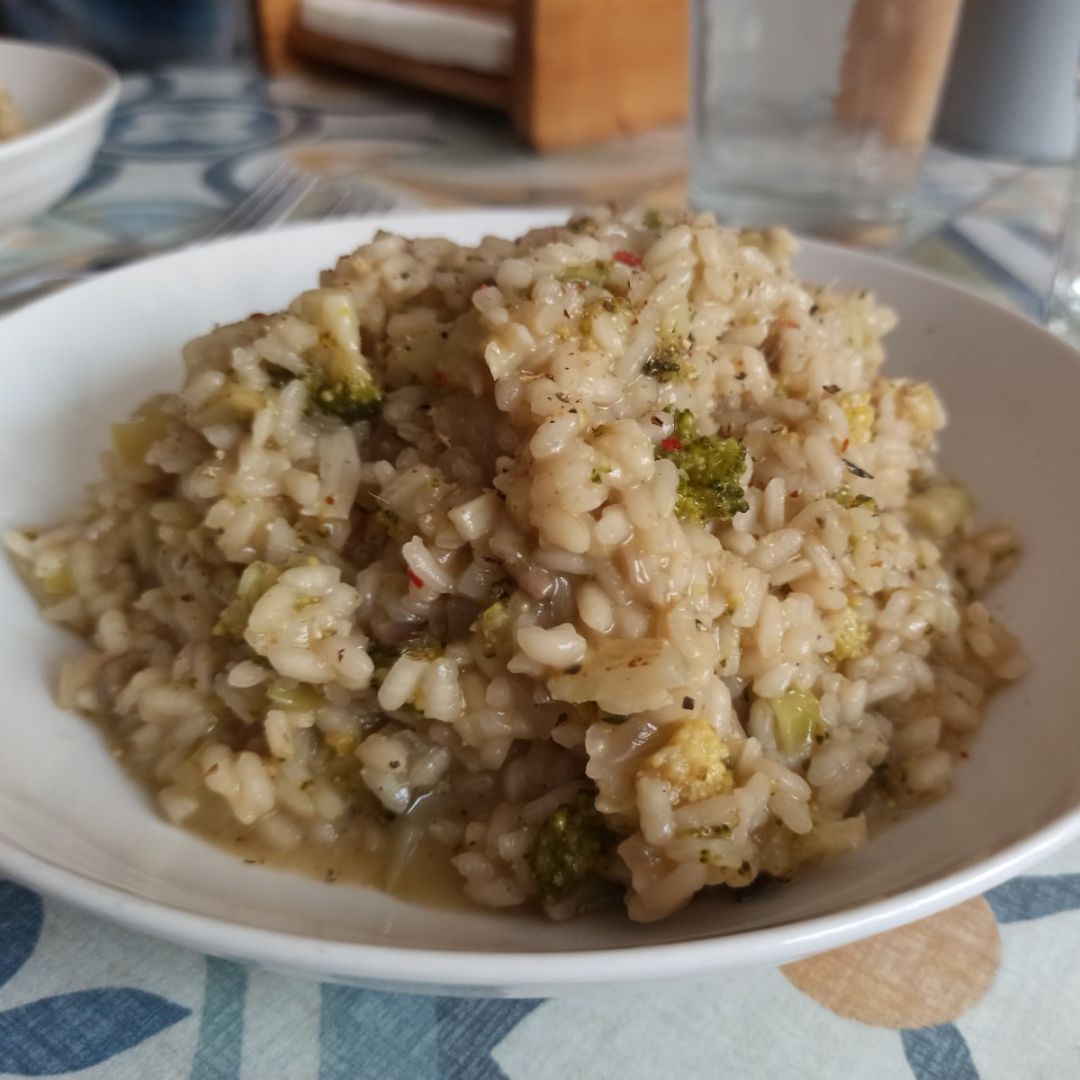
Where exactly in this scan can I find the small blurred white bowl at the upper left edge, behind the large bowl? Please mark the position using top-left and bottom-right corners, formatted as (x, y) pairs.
(0, 39), (120, 231)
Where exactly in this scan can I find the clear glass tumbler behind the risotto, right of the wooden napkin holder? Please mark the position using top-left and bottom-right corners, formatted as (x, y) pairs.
(690, 0), (962, 244)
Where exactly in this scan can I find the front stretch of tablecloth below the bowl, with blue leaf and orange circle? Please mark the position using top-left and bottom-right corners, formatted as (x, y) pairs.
(6, 850), (1080, 1080)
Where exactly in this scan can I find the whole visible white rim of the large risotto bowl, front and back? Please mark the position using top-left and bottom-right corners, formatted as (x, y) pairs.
(0, 206), (1080, 997)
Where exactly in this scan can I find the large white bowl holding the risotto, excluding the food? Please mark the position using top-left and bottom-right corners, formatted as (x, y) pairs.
(0, 212), (1080, 996)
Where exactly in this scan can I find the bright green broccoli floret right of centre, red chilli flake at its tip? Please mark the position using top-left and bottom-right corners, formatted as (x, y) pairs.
(662, 409), (750, 522)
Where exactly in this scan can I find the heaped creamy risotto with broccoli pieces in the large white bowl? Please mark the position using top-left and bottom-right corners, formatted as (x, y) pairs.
(8, 211), (1025, 920)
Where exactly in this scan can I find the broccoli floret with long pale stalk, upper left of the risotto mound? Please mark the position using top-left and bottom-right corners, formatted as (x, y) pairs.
(296, 289), (382, 423)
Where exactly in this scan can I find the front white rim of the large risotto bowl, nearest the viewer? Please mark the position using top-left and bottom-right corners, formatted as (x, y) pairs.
(0, 807), (1080, 997)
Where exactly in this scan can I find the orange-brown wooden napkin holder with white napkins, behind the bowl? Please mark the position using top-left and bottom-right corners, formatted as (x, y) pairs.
(254, 0), (689, 150)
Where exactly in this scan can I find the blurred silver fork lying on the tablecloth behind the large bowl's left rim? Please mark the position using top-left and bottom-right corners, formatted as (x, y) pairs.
(0, 165), (393, 305)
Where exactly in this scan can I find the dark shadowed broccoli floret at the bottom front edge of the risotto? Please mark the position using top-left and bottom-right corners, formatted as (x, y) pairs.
(527, 792), (615, 904)
